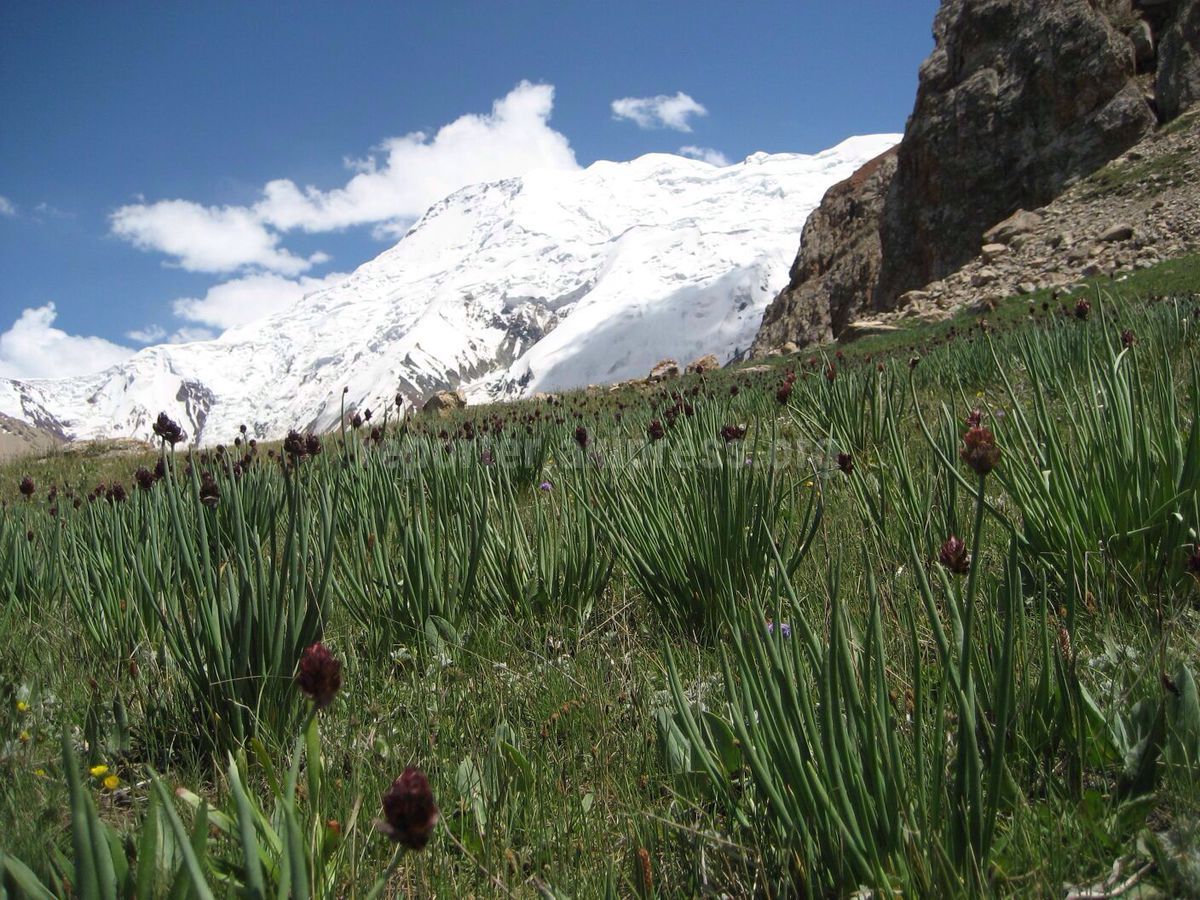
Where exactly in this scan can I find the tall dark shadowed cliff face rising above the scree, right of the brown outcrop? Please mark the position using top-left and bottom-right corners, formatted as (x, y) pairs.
(875, 0), (1157, 308)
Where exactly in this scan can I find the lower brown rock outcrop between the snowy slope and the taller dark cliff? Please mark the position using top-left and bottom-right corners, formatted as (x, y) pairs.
(750, 149), (896, 356)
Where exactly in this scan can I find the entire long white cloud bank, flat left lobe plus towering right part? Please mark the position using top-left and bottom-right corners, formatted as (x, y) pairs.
(110, 82), (578, 277)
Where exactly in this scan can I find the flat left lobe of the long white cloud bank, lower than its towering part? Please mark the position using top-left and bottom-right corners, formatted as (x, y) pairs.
(110, 200), (328, 275)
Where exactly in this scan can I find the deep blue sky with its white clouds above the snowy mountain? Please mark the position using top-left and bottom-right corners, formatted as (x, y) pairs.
(0, 0), (937, 377)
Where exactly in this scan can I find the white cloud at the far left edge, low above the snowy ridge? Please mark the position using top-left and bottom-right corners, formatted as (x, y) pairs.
(0, 304), (133, 378)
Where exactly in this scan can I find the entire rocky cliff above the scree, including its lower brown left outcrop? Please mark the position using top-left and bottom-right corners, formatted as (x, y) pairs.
(754, 0), (1200, 354)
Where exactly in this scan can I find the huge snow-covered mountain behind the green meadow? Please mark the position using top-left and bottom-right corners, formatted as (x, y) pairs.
(0, 134), (900, 443)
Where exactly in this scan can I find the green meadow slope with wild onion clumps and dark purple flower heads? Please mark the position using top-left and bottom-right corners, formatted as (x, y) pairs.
(0, 285), (1200, 898)
